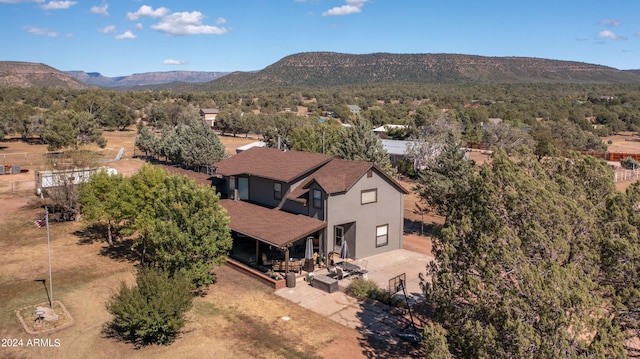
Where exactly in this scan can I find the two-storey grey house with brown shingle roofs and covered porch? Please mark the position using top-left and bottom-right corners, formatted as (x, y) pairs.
(216, 147), (407, 271)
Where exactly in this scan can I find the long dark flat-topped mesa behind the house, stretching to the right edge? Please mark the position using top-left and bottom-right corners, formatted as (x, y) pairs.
(194, 52), (640, 90)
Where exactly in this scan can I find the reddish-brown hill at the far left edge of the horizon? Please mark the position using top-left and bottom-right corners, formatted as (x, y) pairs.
(0, 61), (93, 89)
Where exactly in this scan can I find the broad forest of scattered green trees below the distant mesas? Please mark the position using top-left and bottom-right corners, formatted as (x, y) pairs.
(0, 84), (640, 157)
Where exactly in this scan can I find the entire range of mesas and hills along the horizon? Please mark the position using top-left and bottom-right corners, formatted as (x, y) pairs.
(0, 52), (640, 91)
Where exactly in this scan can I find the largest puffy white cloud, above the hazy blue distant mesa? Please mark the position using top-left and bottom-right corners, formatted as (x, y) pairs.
(151, 11), (227, 36)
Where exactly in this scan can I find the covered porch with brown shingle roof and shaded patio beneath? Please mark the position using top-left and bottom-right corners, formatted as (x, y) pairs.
(220, 200), (326, 275)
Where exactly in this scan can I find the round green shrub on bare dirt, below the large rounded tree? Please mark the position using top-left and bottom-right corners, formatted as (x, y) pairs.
(107, 269), (193, 345)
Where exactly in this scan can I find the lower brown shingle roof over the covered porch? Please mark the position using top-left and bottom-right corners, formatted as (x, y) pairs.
(220, 199), (326, 247)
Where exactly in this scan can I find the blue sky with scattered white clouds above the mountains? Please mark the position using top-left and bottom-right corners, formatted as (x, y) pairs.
(0, 0), (640, 76)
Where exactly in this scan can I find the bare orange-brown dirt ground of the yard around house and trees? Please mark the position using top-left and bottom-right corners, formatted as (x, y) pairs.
(0, 131), (430, 359)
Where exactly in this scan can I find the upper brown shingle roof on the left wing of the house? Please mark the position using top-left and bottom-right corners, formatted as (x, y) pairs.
(216, 147), (332, 183)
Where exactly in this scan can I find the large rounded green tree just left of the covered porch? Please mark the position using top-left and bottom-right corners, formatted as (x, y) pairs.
(128, 166), (231, 288)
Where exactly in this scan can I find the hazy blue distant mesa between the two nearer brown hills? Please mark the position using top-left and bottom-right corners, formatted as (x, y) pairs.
(66, 71), (228, 88)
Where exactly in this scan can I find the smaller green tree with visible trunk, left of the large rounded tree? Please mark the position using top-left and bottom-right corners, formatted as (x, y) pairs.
(78, 170), (127, 246)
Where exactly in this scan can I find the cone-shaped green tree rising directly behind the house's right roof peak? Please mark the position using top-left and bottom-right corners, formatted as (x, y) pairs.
(334, 119), (395, 175)
